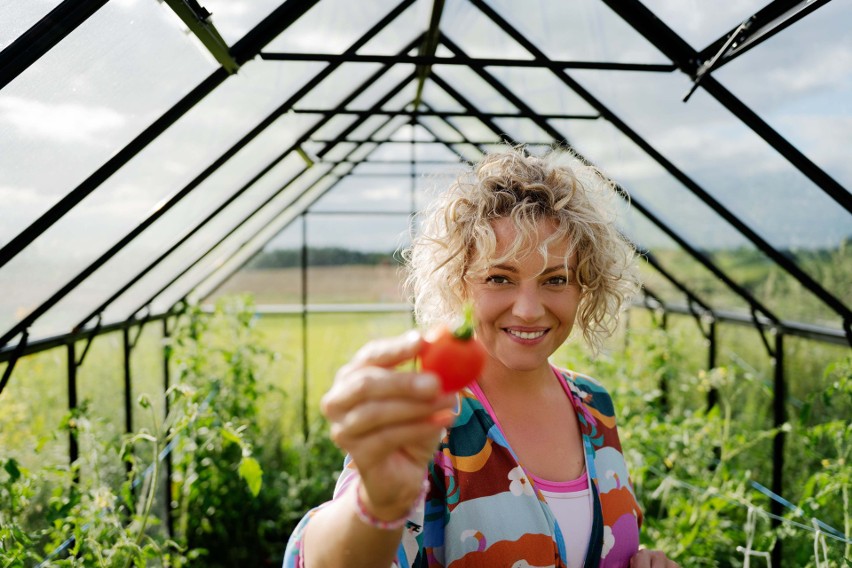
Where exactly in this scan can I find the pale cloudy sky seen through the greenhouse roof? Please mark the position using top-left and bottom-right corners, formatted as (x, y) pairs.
(0, 0), (852, 338)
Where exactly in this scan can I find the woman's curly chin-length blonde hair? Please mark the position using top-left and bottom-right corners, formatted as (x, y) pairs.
(403, 147), (639, 352)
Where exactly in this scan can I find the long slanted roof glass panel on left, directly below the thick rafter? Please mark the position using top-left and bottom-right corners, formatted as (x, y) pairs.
(0, 57), (328, 342)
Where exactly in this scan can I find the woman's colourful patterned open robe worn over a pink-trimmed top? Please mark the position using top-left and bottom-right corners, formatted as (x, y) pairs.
(284, 370), (642, 568)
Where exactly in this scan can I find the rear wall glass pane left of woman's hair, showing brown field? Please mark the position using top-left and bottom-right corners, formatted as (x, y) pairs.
(307, 213), (409, 304)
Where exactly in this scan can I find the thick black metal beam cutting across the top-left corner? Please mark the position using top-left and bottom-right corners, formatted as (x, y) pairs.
(0, 0), (108, 89)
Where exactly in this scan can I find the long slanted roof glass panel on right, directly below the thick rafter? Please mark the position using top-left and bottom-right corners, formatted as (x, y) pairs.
(564, 72), (852, 321)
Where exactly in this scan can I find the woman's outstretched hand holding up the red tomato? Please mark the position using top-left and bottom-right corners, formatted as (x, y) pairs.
(321, 332), (456, 520)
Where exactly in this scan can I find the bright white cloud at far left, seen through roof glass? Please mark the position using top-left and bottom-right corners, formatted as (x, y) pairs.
(0, 97), (127, 145)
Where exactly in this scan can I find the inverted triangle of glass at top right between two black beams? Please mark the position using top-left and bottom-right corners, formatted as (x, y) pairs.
(642, 0), (769, 51)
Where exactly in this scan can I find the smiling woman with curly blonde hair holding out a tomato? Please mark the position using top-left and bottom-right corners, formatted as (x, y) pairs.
(284, 148), (677, 568)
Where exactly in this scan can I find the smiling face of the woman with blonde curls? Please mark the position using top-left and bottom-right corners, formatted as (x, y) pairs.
(468, 218), (580, 378)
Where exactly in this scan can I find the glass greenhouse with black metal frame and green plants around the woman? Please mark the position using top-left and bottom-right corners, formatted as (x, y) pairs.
(0, 0), (852, 568)
